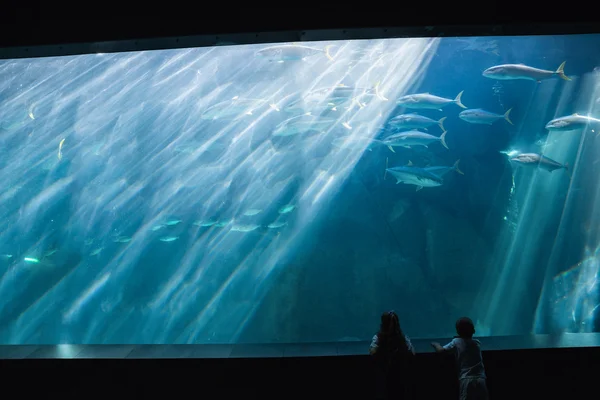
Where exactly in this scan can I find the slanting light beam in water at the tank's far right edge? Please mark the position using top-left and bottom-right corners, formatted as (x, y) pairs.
(535, 73), (600, 333)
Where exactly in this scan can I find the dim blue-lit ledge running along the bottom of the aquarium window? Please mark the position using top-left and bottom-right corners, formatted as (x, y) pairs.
(0, 333), (600, 359)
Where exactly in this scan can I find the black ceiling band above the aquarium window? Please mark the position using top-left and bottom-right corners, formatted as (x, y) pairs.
(0, 0), (600, 47)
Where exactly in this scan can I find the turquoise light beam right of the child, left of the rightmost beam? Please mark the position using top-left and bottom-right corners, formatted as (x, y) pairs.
(472, 70), (596, 335)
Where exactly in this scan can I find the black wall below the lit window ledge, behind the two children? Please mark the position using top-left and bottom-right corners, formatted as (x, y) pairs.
(0, 348), (600, 400)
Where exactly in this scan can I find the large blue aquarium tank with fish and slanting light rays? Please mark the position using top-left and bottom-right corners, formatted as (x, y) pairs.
(0, 35), (600, 344)
